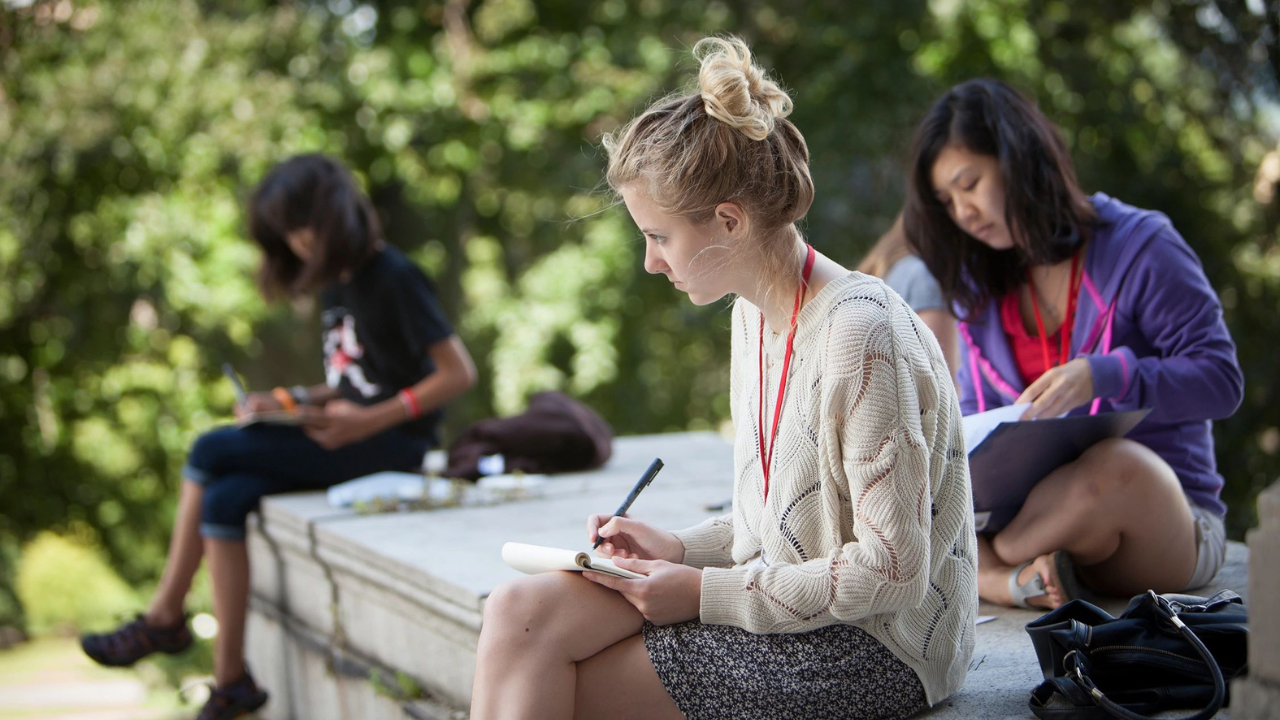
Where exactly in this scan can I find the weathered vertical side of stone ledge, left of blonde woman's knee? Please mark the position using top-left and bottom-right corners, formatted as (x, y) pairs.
(246, 497), (480, 720)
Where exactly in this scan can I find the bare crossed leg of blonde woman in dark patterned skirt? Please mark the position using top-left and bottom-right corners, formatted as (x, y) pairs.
(471, 573), (671, 720)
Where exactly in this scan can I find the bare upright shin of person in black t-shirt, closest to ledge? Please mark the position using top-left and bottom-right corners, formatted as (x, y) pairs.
(205, 538), (248, 687)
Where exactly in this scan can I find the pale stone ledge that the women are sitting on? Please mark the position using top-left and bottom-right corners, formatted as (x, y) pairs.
(247, 433), (1248, 720)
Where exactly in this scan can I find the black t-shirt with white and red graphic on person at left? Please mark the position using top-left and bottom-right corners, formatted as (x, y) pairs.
(320, 245), (453, 445)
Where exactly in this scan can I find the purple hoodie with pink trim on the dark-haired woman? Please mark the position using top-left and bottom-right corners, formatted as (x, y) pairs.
(957, 192), (1244, 516)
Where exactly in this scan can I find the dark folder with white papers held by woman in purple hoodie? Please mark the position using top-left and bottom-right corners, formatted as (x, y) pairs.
(964, 405), (1151, 533)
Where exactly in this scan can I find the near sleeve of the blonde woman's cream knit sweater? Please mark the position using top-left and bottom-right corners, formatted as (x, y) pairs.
(700, 295), (932, 633)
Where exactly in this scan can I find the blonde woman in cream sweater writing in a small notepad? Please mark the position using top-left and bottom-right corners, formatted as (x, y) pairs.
(471, 38), (978, 720)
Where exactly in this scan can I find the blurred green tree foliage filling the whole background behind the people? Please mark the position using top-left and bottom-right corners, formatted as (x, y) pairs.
(0, 0), (1280, 625)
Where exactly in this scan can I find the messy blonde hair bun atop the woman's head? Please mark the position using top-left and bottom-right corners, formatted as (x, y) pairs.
(694, 36), (792, 141)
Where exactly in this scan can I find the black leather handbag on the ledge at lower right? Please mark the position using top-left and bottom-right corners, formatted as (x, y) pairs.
(1027, 591), (1249, 720)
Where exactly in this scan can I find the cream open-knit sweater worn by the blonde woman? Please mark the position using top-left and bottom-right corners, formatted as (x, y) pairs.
(676, 273), (978, 705)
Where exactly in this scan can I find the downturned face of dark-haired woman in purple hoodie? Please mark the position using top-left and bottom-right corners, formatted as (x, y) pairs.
(929, 145), (1015, 250)
